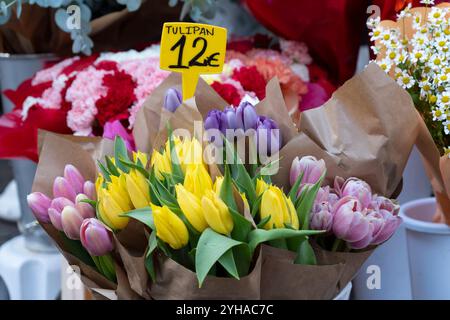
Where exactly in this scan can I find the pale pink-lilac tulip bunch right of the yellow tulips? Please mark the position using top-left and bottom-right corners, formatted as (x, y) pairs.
(290, 156), (401, 251)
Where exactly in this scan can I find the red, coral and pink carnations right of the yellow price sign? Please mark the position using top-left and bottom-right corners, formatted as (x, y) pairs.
(203, 35), (335, 113)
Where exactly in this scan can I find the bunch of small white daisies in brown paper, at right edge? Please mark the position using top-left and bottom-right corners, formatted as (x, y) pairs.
(368, 1), (450, 222)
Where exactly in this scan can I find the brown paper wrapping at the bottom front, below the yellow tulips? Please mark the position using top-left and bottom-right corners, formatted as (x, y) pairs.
(151, 250), (262, 300)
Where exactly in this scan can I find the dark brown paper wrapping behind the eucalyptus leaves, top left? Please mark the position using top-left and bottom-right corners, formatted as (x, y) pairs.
(0, 0), (181, 55)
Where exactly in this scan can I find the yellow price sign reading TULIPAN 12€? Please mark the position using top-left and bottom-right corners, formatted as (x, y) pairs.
(160, 22), (227, 100)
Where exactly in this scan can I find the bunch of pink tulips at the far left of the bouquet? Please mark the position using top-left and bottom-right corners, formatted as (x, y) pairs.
(27, 164), (116, 281)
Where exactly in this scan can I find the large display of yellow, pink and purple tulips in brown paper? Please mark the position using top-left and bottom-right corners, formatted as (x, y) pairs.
(29, 61), (419, 299)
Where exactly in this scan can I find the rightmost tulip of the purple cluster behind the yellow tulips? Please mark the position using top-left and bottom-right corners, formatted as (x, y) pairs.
(256, 116), (281, 156)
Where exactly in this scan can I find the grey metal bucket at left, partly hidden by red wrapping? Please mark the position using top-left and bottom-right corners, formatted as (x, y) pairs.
(0, 53), (57, 252)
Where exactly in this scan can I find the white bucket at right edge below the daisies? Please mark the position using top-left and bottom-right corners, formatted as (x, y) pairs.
(400, 198), (450, 299)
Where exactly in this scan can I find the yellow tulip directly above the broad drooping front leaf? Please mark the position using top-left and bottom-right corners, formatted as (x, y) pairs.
(201, 190), (234, 235)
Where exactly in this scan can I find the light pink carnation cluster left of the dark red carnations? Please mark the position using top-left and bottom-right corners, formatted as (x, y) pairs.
(66, 66), (111, 136)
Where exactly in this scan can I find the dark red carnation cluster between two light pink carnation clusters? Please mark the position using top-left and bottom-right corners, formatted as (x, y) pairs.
(95, 65), (136, 127)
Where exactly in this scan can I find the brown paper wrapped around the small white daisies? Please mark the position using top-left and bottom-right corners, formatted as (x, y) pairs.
(377, 3), (450, 225)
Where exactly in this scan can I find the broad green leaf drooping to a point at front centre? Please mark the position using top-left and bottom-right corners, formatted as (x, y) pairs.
(195, 228), (242, 287)
